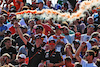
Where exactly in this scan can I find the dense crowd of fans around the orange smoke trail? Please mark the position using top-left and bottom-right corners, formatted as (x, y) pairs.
(0, 0), (100, 67)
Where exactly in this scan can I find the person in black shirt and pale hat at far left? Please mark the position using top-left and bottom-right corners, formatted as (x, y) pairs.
(1, 37), (17, 62)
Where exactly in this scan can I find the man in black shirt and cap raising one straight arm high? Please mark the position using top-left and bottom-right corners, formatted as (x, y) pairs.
(14, 21), (45, 67)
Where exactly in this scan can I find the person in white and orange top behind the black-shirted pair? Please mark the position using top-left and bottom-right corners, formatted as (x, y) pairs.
(49, 25), (68, 52)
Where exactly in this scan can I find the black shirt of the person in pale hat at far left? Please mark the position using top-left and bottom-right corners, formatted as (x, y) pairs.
(1, 46), (17, 58)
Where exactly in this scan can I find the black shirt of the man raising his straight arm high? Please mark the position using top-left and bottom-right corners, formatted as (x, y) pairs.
(26, 42), (45, 67)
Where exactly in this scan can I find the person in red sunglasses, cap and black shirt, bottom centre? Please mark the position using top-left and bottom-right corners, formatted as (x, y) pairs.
(47, 40), (63, 67)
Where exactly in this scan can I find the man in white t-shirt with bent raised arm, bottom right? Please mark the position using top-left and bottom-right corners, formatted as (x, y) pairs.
(75, 42), (97, 67)
